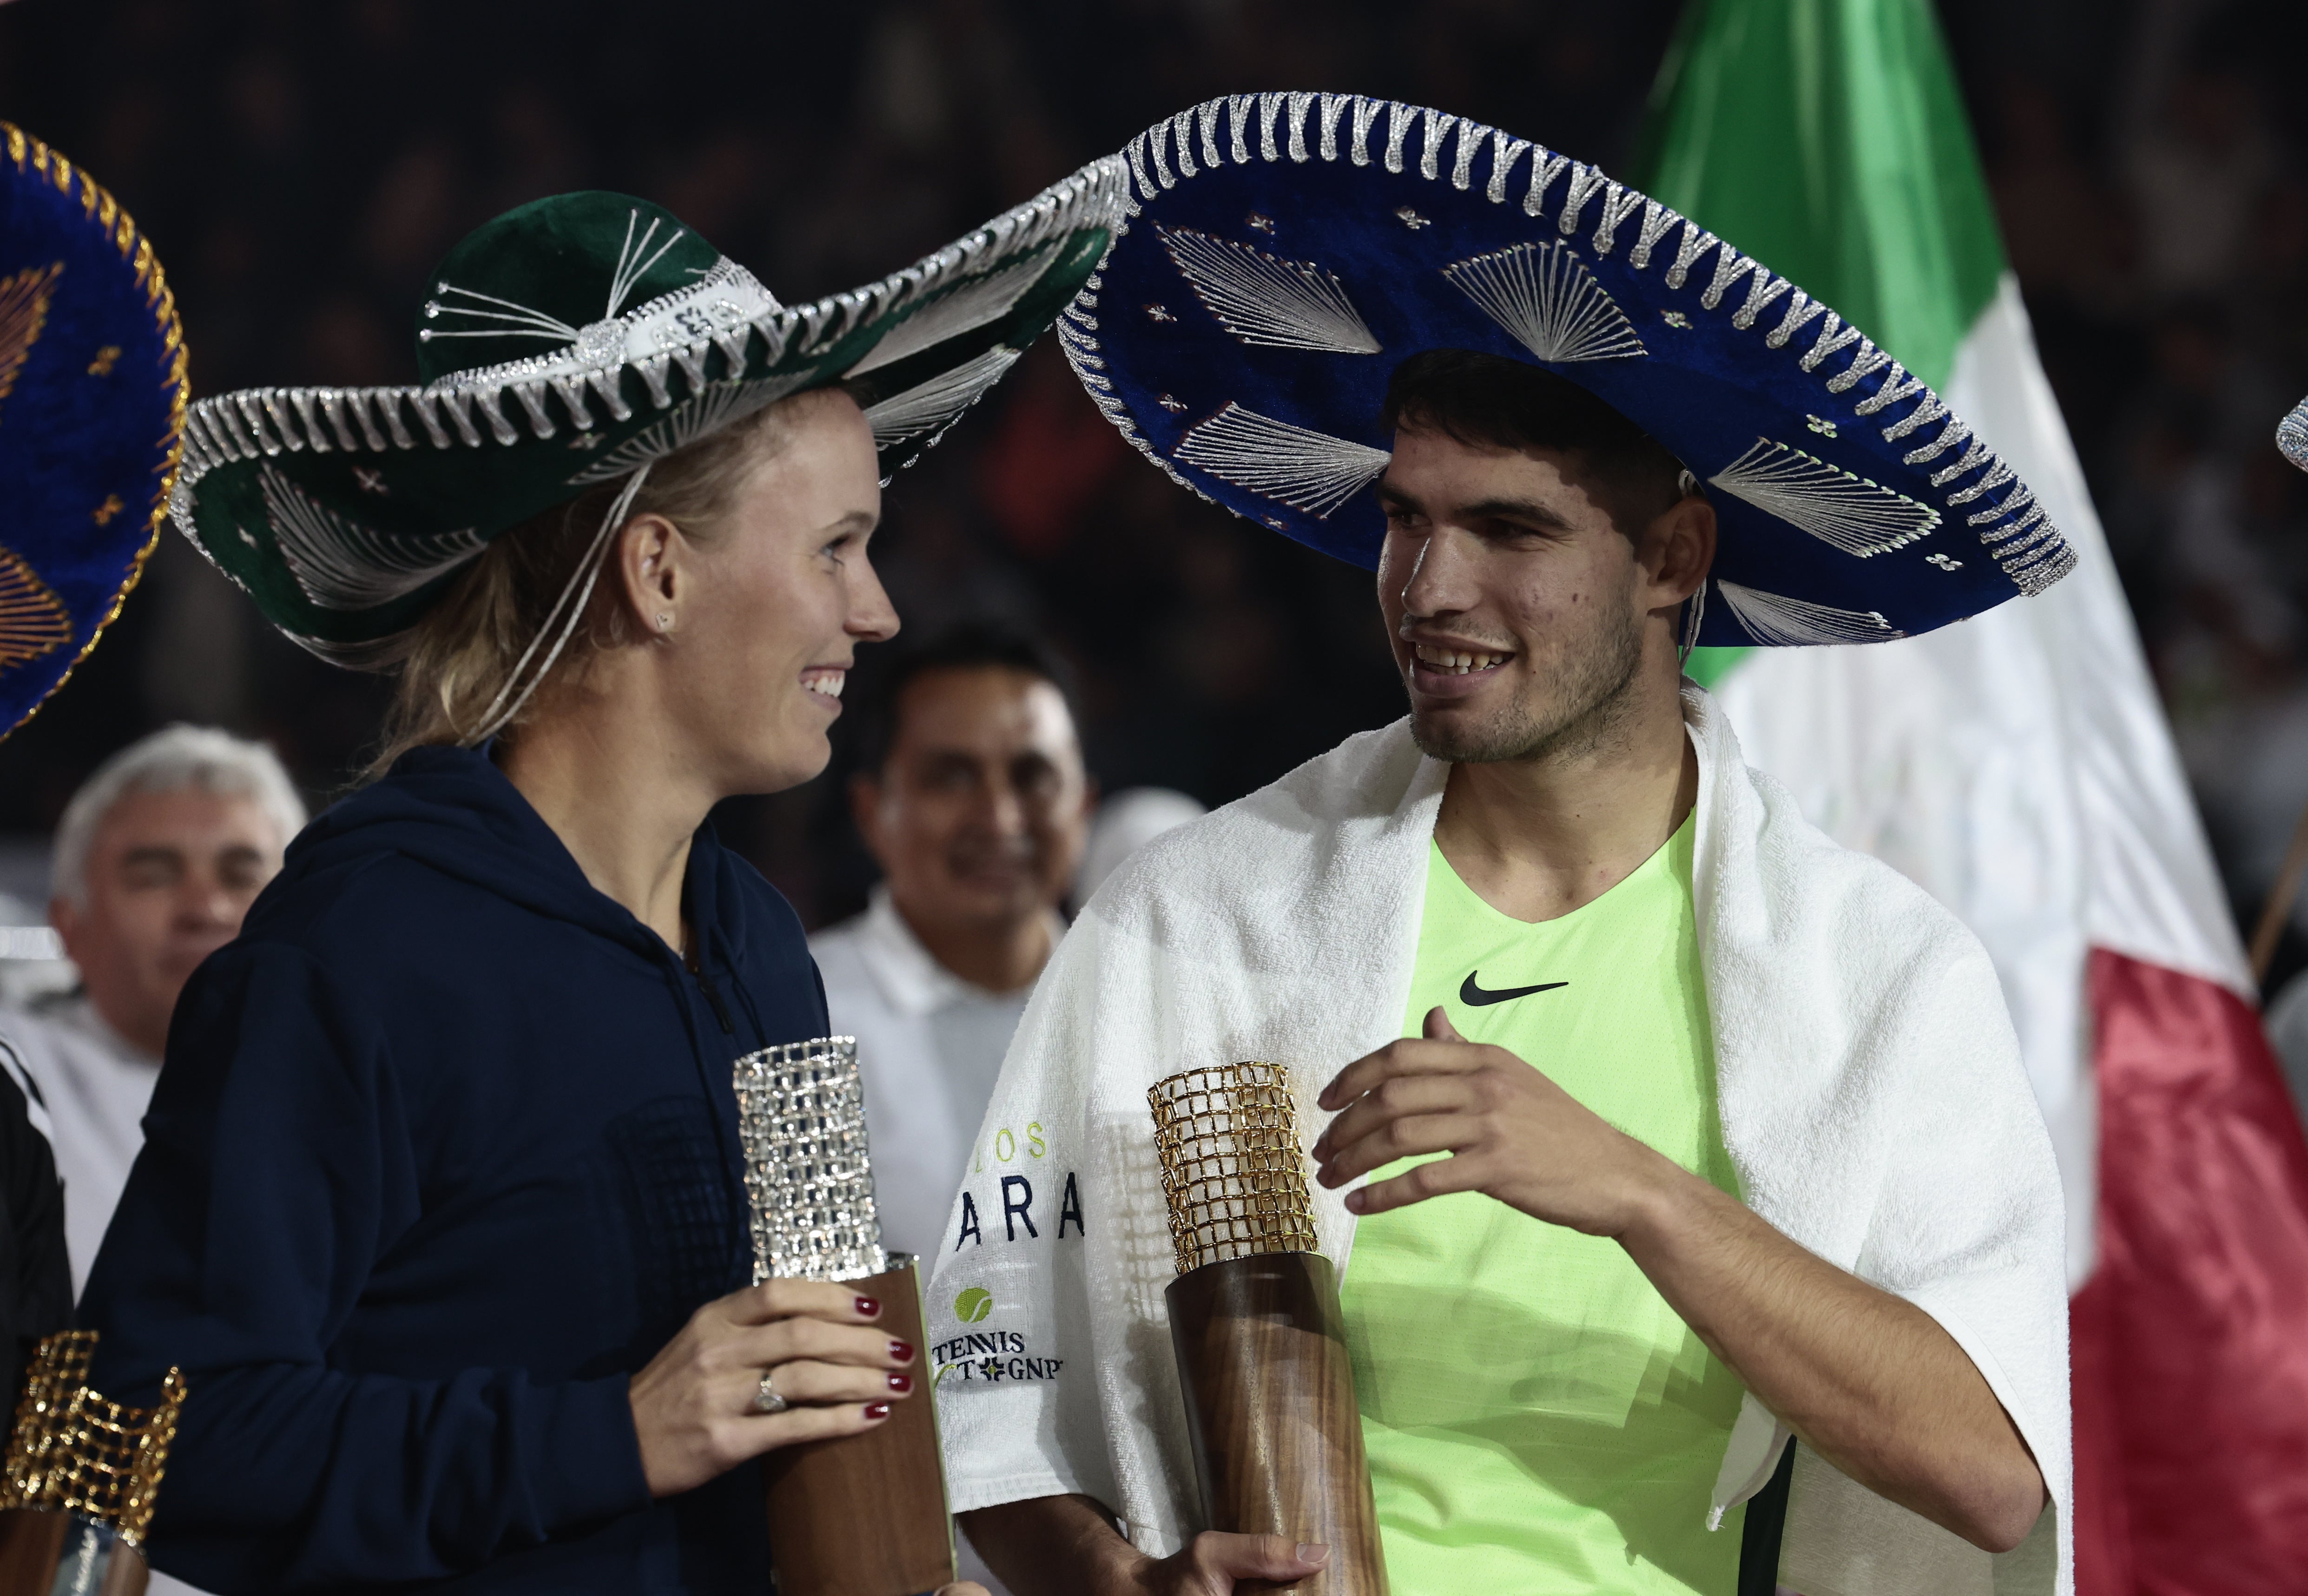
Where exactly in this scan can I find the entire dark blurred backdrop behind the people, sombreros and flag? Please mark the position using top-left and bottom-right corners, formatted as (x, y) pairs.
(0, 0), (2308, 946)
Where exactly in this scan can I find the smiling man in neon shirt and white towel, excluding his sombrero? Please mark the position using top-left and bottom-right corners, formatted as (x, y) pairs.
(932, 351), (2066, 1596)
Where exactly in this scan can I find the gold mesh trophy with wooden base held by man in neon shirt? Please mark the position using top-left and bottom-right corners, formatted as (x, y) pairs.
(1147, 1063), (1387, 1596)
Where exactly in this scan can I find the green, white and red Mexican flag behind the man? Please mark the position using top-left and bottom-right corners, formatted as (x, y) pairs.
(1636, 0), (2308, 1596)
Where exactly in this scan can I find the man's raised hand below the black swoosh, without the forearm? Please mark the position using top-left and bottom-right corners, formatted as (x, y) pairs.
(1313, 1008), (1696, 1236)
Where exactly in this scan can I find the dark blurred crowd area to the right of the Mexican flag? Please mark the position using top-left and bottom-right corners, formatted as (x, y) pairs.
(1969, 0), (2308, 973)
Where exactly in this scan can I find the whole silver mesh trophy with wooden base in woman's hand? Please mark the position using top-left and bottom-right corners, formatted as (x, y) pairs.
(739, 1036), (953, 1596)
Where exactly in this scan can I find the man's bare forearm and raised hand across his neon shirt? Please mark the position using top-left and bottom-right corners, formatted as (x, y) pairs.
(1313, 1008), (2045, 1552)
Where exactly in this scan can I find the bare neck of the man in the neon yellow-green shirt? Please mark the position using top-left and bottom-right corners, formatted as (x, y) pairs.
(1436, 673), (1699, 923)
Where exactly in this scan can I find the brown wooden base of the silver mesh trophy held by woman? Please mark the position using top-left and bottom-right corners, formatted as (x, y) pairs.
(761, 1259), (953, 1596)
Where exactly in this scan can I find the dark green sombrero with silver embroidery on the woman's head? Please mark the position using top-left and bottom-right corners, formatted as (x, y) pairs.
(169, 168), (1128, 669)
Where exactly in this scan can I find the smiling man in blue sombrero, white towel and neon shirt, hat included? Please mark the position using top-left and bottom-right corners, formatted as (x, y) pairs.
(930, 95), (2075, 1596)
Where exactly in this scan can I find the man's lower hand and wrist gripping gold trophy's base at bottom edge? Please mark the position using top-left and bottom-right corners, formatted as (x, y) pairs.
(963, 1497), (1329, 1596)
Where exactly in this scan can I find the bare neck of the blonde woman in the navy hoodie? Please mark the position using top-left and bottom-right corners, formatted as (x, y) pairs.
(499, 699), (715, 950)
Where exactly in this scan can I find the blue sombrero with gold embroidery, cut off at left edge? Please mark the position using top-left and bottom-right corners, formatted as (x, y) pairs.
(0, 122), (185, 736)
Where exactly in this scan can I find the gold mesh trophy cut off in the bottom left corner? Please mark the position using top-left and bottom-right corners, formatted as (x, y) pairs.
(0, 1331), (185, 1596)
